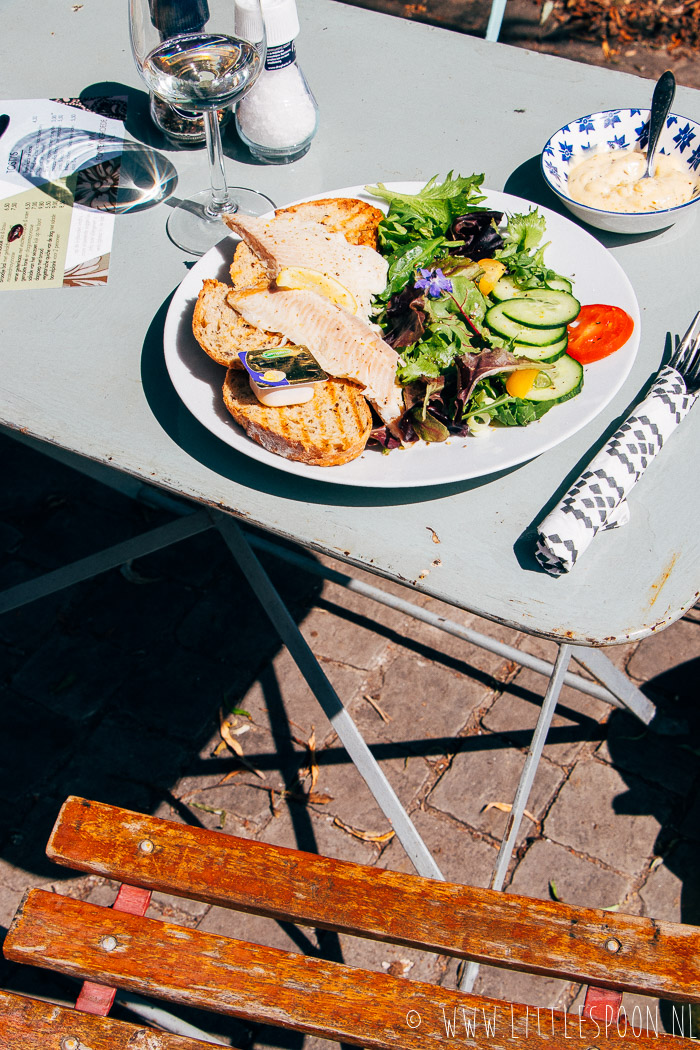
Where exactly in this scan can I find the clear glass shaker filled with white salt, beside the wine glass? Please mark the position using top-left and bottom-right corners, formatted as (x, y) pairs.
(236, 0), (318, 164)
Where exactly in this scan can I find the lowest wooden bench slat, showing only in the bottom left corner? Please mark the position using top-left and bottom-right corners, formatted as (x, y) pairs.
(0, 991), (212, 1050)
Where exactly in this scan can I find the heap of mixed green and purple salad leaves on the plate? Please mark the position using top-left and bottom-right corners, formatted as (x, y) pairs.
(365, 171), (579, 441)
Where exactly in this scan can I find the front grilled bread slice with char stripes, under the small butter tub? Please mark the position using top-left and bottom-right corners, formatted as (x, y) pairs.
(224, 369), (372, 466)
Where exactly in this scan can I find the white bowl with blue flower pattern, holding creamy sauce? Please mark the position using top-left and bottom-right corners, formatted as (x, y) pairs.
(542, 109), (700, 234)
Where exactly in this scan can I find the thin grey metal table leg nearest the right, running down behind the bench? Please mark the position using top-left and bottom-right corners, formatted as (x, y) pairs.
(460, 645), (574, 991)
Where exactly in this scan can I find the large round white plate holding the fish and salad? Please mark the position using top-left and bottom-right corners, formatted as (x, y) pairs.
(164, 183), (640, 488)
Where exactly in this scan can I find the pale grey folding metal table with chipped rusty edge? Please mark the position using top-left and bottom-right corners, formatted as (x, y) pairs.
(0, 0), (700, 1020)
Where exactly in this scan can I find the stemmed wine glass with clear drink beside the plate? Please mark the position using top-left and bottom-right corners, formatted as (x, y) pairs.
(129, 0), (274, 255)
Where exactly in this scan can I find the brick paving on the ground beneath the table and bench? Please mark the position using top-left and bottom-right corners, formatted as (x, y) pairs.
(0, 430), (700, 1050)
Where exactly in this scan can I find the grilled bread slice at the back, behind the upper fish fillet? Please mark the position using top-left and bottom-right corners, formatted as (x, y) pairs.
(230, 197), (384, 291)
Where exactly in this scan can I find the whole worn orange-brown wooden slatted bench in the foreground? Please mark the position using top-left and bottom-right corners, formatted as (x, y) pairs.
(0, 798), (700, 1050)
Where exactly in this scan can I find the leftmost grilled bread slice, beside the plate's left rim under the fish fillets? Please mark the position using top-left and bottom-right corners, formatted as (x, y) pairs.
(192, 279), (283, 369)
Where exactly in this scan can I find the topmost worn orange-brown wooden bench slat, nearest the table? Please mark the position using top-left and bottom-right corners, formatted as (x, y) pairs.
(47, 797), (700, 1002)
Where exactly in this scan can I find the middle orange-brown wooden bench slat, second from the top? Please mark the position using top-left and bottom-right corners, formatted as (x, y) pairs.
(4, 889), (697, 1050)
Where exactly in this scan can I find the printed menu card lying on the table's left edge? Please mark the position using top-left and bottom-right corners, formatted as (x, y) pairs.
(0, 98), (126, 292)
